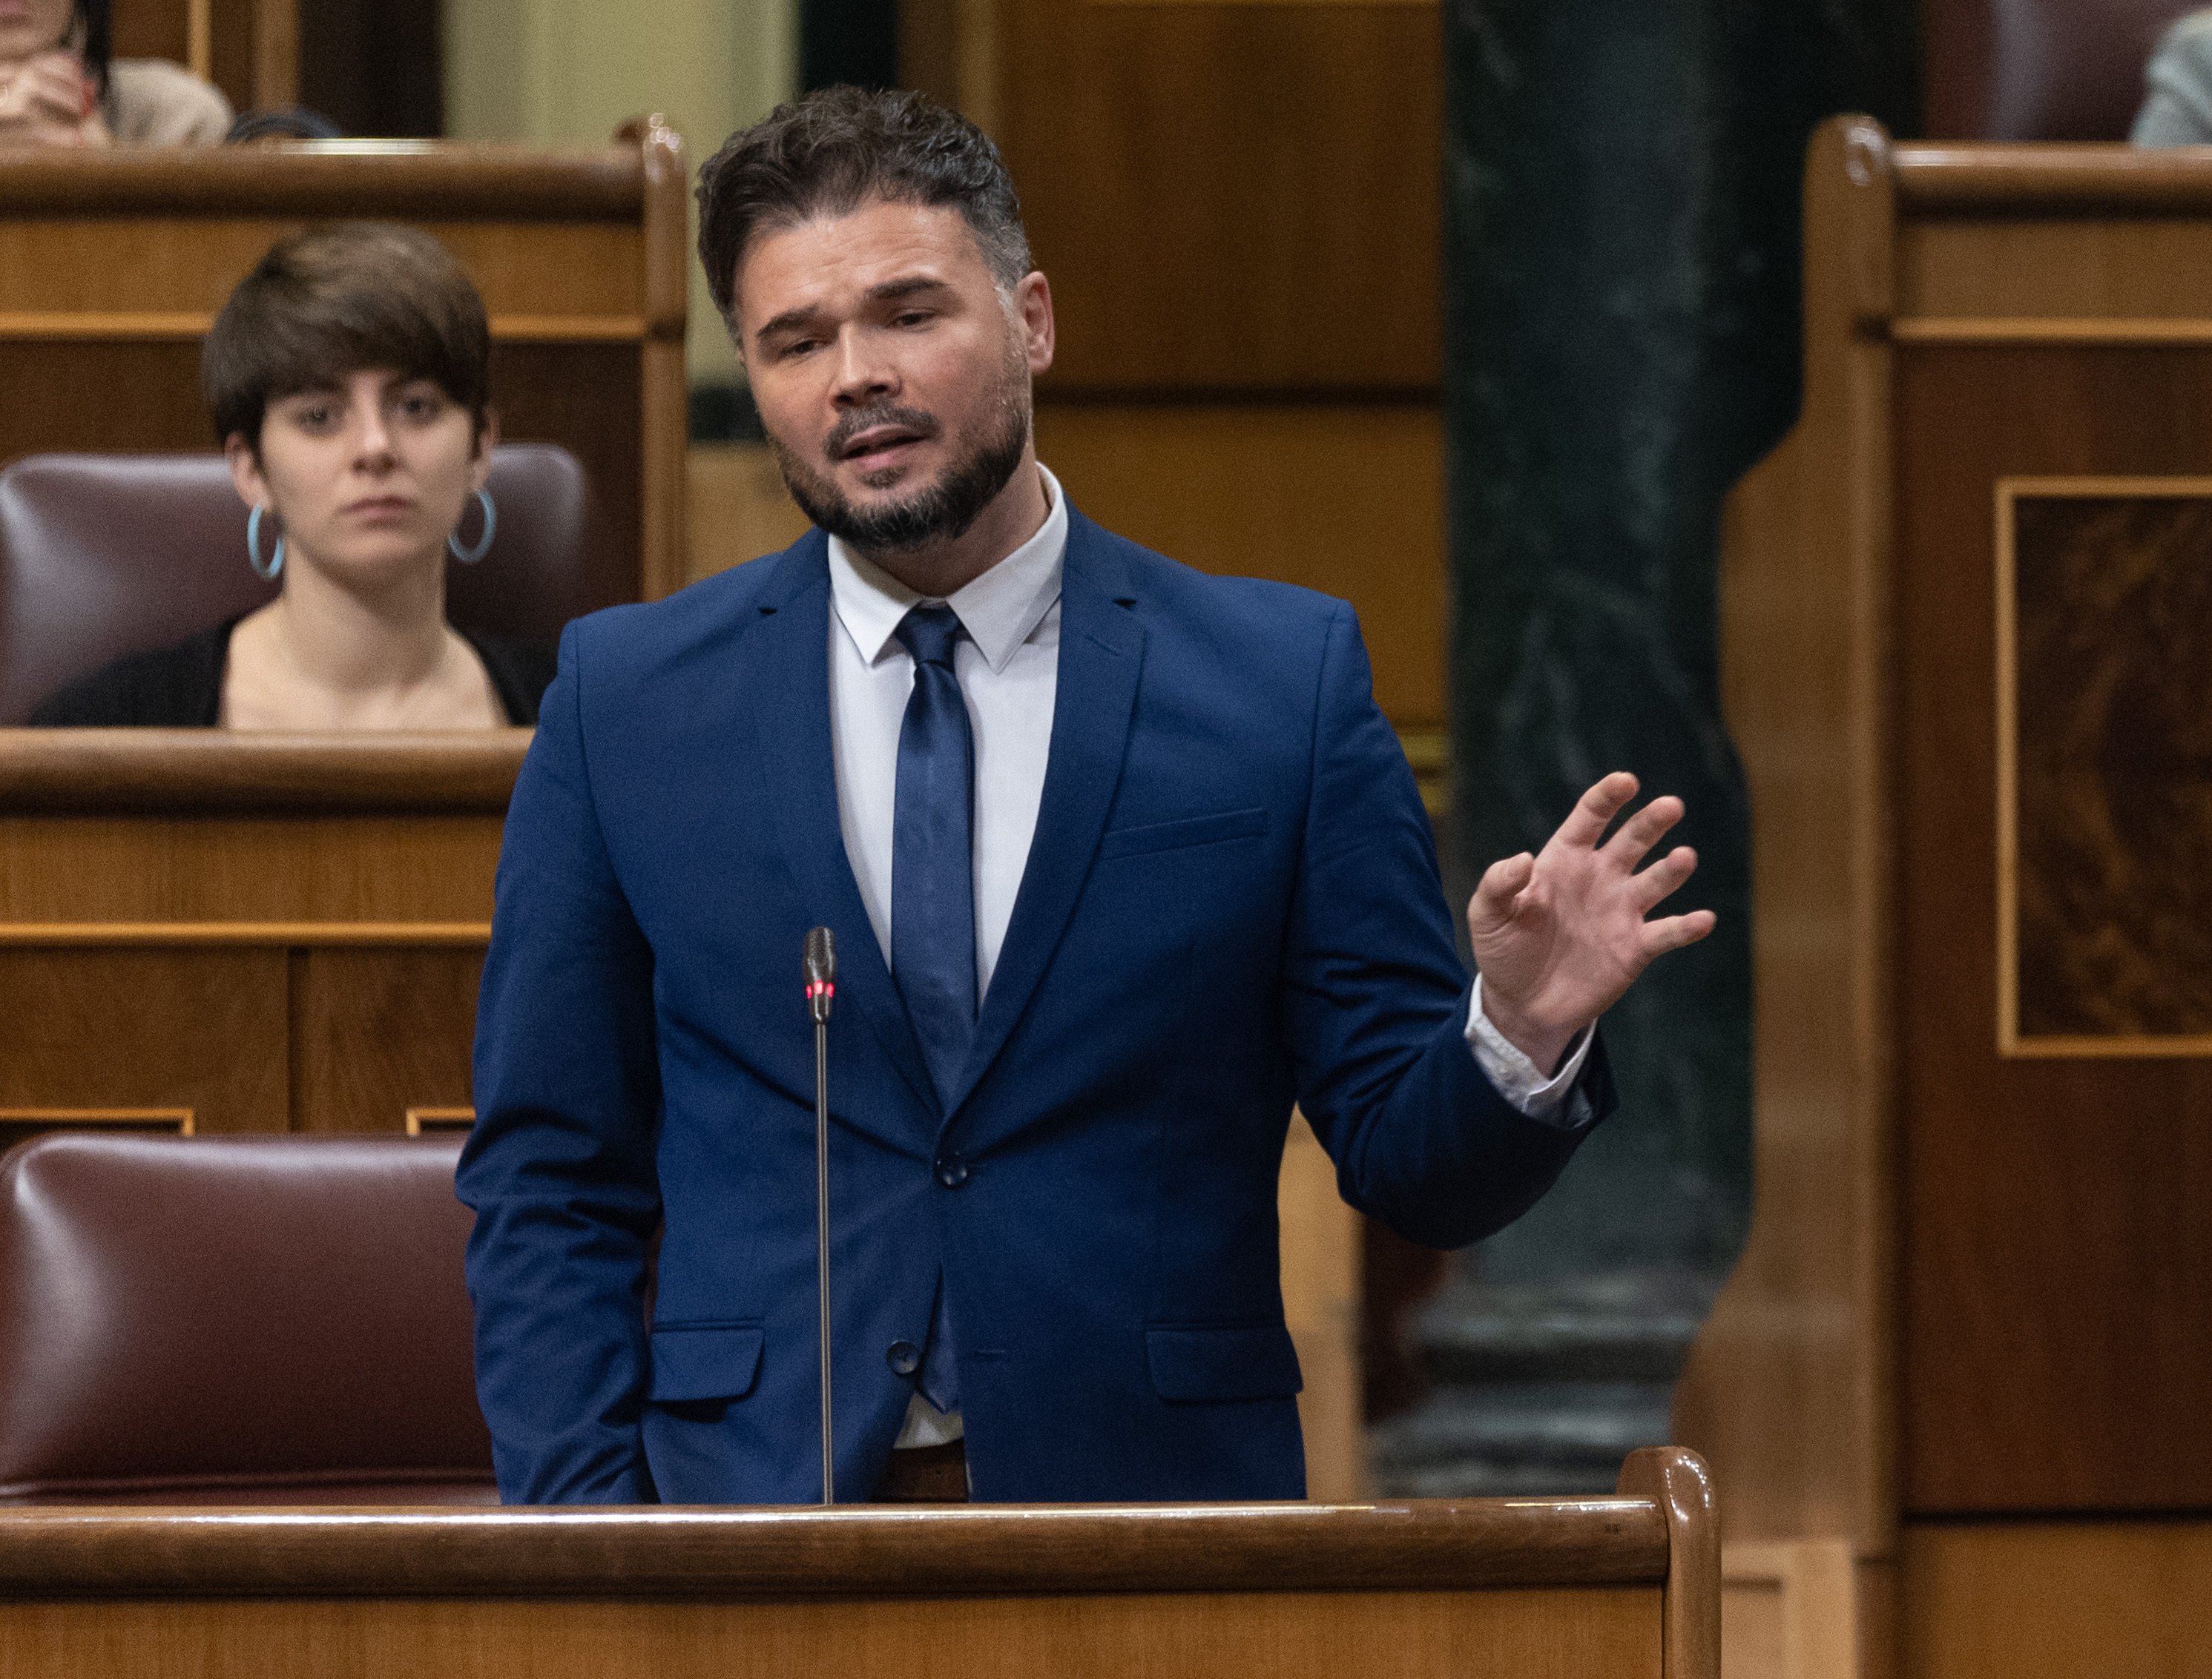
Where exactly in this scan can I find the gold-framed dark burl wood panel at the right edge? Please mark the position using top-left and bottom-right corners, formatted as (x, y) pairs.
(1995, 475), (2212, 1058)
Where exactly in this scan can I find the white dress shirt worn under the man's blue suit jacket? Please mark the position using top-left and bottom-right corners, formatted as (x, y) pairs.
(829, 466), (1590, 1447)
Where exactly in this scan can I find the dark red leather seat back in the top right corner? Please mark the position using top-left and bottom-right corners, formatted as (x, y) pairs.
(1922, 0), (2203, 139)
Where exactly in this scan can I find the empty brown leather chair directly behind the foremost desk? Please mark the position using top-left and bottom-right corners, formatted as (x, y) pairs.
(0, 1130), (496, 1504)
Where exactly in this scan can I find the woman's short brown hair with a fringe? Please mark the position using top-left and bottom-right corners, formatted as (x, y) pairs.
(199, 221), (491, 453)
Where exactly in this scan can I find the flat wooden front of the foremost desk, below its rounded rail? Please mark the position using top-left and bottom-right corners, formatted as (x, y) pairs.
(0, 1589), (1659, 1679)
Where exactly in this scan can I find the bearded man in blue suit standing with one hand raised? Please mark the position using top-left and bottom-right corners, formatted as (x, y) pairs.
(460, 88), (1712, 1502)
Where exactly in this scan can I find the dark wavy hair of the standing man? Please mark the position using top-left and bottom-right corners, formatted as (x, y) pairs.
(699, 86), (1029, 321)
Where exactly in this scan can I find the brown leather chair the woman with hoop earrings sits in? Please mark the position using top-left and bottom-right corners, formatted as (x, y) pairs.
(0, 443), (595, 725)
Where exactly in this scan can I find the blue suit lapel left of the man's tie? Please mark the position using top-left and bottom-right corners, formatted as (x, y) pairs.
(745, 531), (938, 1115)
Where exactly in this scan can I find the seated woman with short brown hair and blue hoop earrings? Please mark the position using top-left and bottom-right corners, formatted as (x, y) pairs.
(31, 221), (553, 730)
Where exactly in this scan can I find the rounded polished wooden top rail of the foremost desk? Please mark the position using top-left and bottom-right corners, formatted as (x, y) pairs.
(0, 1497), (1663, 1602)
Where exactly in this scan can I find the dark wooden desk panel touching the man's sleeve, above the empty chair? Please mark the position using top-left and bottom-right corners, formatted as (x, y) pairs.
(292, 949), (484, 1130)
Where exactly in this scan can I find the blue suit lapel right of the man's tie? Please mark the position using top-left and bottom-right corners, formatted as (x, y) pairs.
(940, 507), (1144, 1135)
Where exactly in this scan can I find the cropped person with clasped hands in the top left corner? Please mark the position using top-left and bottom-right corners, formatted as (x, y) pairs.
(0, 0), (230, 146)
